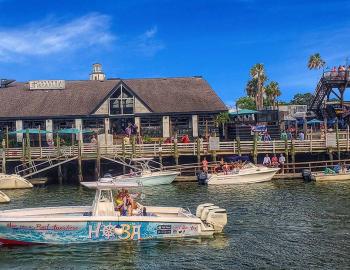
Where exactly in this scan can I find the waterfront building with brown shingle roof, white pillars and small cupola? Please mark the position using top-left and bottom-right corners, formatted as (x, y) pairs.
(0, 64), (227, 142)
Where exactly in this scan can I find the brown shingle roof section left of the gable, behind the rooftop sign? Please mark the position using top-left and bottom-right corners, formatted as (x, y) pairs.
(0, 80), (119, 118)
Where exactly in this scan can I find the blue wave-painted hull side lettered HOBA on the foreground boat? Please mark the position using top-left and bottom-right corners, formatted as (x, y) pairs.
(0, 220), (207, 245)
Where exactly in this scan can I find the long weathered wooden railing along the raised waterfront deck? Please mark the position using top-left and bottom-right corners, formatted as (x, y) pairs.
(1, 138), (350, 160)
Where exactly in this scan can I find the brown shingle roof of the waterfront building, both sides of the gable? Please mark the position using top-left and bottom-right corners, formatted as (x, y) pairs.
(0, 77), (226, 118)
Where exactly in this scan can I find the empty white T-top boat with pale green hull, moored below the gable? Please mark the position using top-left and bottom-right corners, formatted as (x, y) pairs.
(81, 158), (179, 188)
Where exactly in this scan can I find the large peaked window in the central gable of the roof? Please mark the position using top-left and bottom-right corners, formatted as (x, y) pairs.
(109, 85), (135, 115)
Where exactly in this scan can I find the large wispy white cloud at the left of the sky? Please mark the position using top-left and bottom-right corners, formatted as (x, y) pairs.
(0, 13), (115, 61)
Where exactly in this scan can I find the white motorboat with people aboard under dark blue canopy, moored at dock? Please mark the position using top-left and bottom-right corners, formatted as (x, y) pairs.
(207, 163), (279, 185)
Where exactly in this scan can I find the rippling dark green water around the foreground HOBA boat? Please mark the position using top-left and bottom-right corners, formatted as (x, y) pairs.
(0, 181), (350, 269)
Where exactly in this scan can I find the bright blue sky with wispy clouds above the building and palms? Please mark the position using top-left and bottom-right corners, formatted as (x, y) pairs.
(0, 0), (350, 104)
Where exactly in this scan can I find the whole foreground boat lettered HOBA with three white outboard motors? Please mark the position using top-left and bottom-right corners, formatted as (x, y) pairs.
(0, 189), (227, 245)
